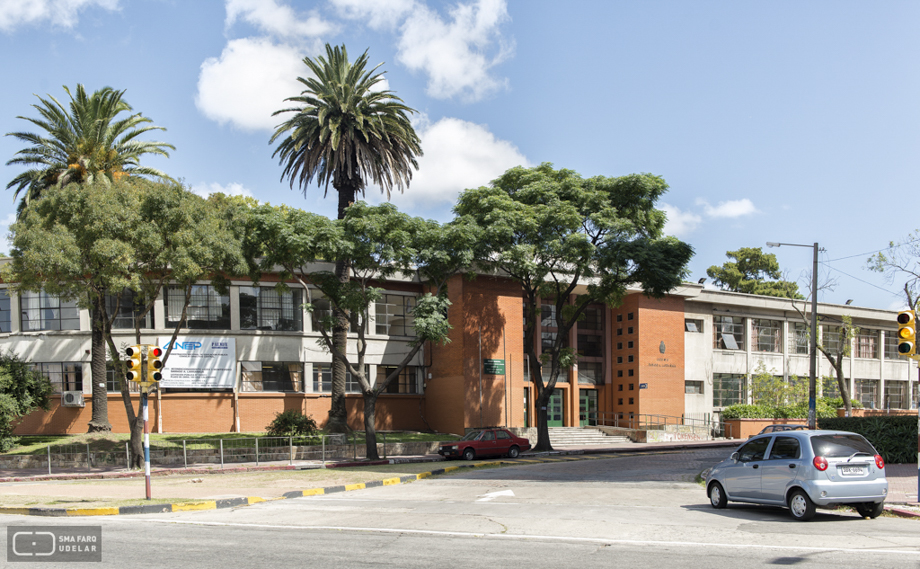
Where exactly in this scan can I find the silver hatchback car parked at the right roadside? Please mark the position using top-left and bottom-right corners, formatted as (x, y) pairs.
(706, 431), (888, 521)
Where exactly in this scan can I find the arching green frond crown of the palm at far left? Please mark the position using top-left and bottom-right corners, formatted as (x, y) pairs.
(6, 85), (175, 215)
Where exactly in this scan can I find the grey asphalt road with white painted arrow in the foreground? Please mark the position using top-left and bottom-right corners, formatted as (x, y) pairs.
(0, 449), (920, 569)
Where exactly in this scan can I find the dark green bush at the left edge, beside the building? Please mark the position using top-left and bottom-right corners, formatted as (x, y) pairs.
(0, 352), (53, 451)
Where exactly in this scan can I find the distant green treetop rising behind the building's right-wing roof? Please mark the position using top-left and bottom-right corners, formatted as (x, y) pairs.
(706, 247), (803, 299)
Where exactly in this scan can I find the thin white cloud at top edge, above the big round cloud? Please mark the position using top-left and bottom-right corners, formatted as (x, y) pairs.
(226, 0), (335, 39)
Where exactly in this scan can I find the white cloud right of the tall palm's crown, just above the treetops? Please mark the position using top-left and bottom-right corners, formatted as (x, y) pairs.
(367, 117), (530, 209)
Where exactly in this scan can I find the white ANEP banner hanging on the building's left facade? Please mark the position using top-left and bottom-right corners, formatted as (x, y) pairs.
(159, 336), (236, 389)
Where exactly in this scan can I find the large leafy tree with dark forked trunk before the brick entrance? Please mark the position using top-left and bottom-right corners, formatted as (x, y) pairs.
(454, 163), (693, 451)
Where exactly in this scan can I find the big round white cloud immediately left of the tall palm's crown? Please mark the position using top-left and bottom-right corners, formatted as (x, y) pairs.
(195, 38), (308, 130)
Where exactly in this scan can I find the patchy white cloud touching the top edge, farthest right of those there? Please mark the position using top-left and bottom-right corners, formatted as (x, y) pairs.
(396, 0), (513, 101)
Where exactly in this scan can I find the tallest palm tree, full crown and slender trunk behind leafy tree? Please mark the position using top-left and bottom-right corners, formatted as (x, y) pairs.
(269, 44), (422, 432)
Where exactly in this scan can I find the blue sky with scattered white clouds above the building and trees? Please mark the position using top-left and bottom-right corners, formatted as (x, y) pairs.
(0, 0), (920, 308)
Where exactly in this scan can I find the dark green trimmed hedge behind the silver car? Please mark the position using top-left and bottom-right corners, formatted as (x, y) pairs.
(818, 415), (917, 464)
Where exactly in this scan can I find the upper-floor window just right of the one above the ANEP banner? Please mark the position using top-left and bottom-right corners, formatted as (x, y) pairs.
(240, 286), (303, 332)
